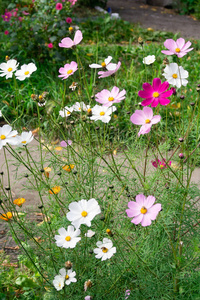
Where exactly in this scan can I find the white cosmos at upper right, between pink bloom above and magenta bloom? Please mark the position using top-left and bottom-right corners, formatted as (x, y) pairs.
(162, 63), (189, 88)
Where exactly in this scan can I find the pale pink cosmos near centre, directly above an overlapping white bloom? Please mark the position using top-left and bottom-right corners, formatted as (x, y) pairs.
(95, 86), (126, 107)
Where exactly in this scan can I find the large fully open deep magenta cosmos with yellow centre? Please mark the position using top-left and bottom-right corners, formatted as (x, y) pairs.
(138, 78), (173, 107)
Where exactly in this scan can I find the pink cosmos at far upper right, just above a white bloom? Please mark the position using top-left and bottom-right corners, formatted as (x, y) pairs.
(161, 38), (193, 57)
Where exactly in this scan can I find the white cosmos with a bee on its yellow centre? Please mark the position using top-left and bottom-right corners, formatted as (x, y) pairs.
(93, 238), (116, 261)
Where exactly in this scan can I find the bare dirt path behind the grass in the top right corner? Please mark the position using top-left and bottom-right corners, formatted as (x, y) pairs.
(107, 0), (200, 39)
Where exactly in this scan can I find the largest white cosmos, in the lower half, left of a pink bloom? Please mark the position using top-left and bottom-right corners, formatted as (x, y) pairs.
(66, 198), (101, 228)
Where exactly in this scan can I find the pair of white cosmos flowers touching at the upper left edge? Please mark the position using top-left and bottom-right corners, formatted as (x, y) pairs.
(0, 59), (37, 81)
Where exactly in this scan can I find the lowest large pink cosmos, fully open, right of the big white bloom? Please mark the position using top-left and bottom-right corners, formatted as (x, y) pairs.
(126, 194), (162, 227)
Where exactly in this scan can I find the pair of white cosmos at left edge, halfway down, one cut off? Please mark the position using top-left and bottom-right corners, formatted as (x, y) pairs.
(0, 125), (33, 149)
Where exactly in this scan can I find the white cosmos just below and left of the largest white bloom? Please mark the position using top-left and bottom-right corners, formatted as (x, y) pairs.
(55, 225), (81, 248)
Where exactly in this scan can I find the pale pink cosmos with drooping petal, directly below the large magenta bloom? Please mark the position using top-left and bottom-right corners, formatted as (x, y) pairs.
(130, 107), (161, 136)
